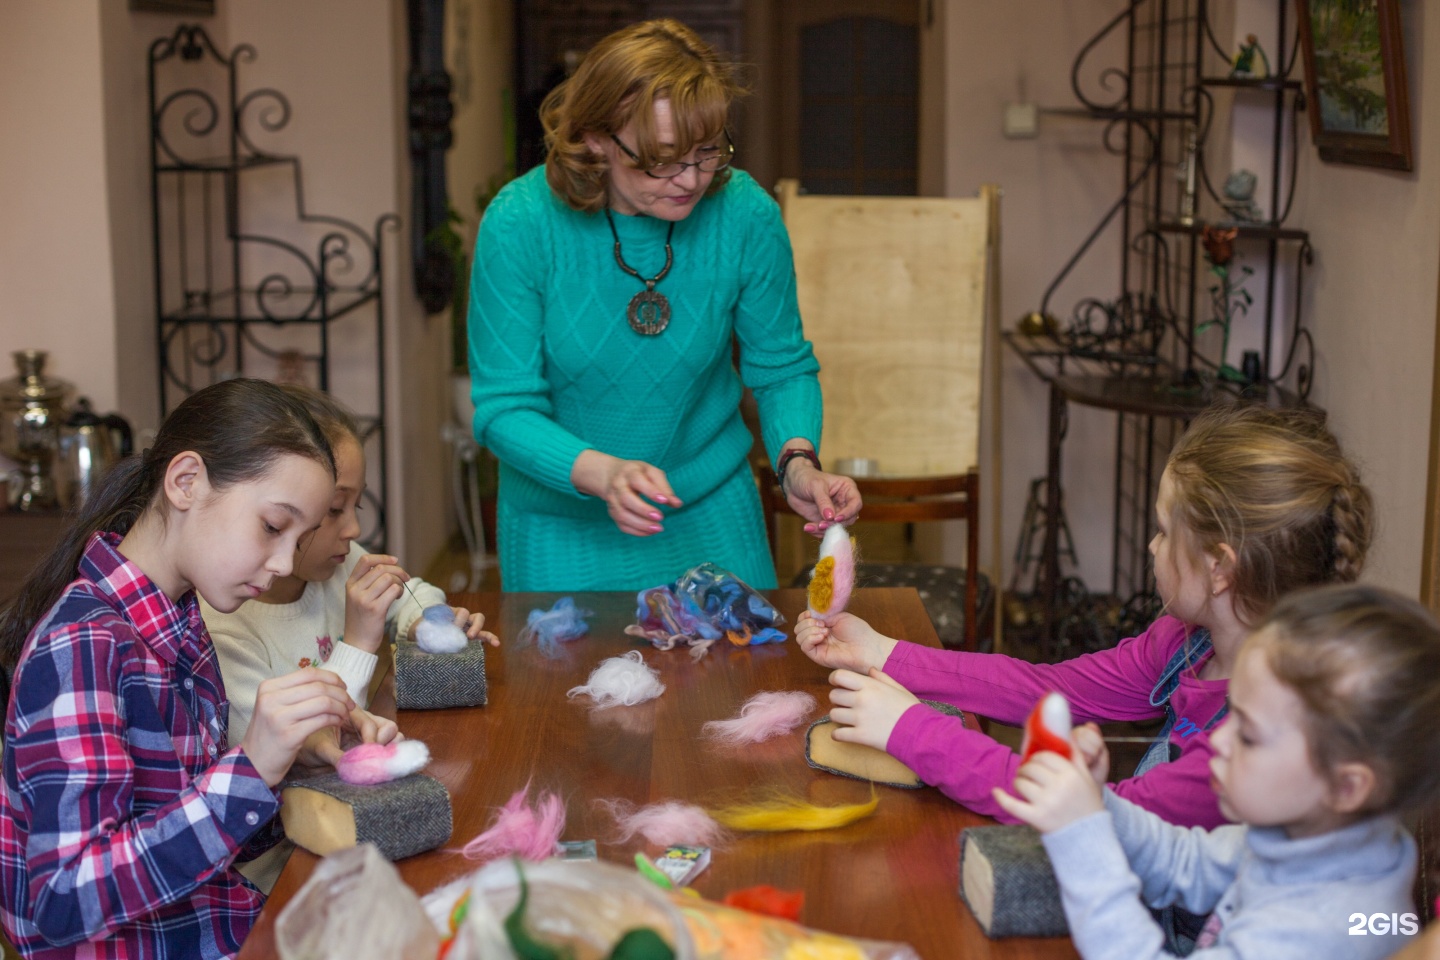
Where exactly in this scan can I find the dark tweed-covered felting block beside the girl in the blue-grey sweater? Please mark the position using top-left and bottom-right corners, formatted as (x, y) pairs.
(960, 823), (1070, 938)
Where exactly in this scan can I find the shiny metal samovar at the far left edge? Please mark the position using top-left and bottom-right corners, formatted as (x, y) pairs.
(0, 350), (72, 510)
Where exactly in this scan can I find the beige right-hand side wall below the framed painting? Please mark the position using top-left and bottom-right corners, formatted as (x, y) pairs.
(1295, 0), (1440, 594)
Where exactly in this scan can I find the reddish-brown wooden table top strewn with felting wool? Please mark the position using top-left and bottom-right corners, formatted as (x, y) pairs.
(240, 589), (1079, 960)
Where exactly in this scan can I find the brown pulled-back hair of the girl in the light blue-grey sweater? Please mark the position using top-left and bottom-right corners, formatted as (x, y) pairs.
(1243, 584), (1440, 813)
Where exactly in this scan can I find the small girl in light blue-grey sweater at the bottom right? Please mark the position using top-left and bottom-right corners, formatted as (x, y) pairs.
(995, 586), (1440, 960)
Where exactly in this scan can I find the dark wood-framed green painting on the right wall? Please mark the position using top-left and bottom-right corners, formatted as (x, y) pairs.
(1296, 0), (1413, 170)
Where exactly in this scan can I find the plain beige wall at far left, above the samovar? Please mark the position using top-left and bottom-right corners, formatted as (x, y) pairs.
(0, 0), (118, 410)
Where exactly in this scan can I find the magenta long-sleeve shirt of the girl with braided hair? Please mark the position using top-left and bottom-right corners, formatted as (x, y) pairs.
(884, 616), (1230, 829)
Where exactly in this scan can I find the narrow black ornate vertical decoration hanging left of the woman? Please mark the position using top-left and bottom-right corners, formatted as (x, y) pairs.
(406, 0), (456, 314)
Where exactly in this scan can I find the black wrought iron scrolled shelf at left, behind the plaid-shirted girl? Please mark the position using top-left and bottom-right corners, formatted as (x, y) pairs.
(148, 24), (399, 551)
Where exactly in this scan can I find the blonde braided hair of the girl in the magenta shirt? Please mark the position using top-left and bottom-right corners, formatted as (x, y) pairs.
(1166, 404), (1374, 623)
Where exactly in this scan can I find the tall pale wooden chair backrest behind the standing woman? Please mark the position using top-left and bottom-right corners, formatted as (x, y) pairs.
(778, 180), (998, 476)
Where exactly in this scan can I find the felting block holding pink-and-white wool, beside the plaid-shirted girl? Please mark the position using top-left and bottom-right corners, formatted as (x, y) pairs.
(279, 773), (454, 861)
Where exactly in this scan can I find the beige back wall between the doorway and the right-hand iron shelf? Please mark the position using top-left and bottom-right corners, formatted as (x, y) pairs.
(937, 0), (1123, 589)
